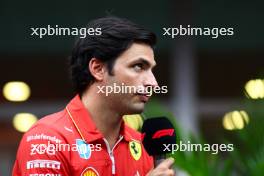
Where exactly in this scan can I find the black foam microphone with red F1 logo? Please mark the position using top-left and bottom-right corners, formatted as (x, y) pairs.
(142, 117), (176, 167)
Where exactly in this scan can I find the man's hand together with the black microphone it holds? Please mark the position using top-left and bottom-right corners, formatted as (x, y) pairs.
(142, 117), (176, 176)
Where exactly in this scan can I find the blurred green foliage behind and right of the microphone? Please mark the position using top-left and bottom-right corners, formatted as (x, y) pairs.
(144, 99), (264, 176)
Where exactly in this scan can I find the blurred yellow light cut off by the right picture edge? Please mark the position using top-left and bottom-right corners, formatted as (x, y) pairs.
(245, 79), (264, 99)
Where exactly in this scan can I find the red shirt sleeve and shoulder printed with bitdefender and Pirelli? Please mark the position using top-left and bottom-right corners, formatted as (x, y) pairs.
(14, 111), (72, 174)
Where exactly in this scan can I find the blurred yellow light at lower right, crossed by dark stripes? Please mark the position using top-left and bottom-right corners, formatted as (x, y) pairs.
(223, 111), (249, 130)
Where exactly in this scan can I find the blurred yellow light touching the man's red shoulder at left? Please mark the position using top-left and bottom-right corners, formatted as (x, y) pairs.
(13, 113), (38, 132)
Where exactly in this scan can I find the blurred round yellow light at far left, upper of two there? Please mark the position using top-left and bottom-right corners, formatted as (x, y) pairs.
(3, 81), (30, 101)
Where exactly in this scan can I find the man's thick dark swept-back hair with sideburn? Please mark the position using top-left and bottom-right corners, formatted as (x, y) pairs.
(70, 17), (156, 95)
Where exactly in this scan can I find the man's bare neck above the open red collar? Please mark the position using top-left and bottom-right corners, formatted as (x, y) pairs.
(81, 86), (122, 148)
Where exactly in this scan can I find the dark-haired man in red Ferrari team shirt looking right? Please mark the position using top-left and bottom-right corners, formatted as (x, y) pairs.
(13, 17), (174, 176)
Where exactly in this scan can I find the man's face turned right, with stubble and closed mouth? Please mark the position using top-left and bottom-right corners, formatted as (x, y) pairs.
(105, 43), (157, 114)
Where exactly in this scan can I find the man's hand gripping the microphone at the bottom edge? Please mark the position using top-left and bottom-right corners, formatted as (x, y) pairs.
(147, 158), (175, 176)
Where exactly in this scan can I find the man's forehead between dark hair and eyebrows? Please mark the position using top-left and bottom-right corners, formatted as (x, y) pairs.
(116, 43), (156, 65)
